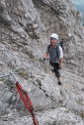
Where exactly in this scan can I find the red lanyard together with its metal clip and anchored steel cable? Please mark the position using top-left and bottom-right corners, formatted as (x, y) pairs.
(0, 69), (39, 125)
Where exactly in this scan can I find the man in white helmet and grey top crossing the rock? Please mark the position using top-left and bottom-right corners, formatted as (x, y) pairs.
(44, 33), (63, 85)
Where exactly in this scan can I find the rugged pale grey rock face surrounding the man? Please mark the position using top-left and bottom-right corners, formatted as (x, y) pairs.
(0, 0), (84, 125)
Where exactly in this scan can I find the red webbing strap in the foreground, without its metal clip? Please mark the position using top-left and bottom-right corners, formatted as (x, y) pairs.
(16, 82), (39, 125)
